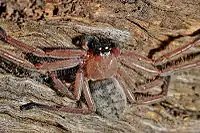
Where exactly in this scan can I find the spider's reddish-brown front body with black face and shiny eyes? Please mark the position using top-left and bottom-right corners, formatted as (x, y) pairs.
(78, 36), (119, 81)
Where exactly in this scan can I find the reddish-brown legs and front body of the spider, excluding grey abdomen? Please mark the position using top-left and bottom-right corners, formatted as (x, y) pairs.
(0, 28), (200, 114)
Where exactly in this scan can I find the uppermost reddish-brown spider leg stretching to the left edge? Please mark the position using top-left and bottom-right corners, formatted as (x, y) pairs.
(0, 27), (87, 58)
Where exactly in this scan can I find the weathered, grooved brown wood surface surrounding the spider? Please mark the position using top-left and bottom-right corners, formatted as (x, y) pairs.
(0, 0), (200, 132)
